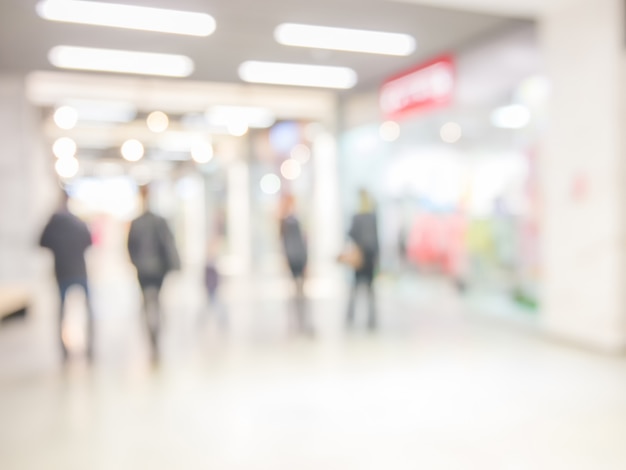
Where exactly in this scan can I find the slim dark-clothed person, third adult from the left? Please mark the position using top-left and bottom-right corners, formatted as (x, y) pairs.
(280, 194), (312, 333)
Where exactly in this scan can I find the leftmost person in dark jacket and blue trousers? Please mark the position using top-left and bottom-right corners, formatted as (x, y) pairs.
(39, 192), (93, 361)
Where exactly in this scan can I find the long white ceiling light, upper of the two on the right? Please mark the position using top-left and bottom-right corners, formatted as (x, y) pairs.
(274, 23), (415, 56)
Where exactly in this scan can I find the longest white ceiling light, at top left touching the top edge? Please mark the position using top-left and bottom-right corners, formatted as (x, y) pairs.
(37, 0), (215, 36)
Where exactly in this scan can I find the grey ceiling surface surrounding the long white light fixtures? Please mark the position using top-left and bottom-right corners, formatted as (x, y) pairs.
(0, 0), (522, 91)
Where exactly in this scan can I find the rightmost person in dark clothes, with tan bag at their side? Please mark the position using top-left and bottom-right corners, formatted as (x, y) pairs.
(346, 190), (379, 330)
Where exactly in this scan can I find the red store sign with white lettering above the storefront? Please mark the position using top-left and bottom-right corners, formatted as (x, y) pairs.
(379, 55), (455, 119)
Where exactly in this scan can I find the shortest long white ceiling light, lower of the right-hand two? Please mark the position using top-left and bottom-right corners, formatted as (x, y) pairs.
(239, 60), (357, 90)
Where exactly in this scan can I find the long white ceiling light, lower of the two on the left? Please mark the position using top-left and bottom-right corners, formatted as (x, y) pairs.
(48, 46), (194, 77)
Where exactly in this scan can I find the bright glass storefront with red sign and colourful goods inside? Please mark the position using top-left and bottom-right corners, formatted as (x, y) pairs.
(340, 23), (548, 311)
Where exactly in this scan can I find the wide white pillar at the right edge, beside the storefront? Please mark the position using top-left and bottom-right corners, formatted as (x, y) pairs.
(540, 0), (626, 350)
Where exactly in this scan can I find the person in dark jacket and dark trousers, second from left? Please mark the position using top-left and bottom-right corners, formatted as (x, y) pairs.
(128, 186), (180, 360)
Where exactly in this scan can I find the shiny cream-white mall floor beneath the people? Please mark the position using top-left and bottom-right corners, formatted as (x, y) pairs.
(0, 264), (626, 470)
